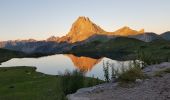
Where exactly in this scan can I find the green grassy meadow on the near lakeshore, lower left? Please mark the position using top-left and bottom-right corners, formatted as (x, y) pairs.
(0, 67), (101, 100)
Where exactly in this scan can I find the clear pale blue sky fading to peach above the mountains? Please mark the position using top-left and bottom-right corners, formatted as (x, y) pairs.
(0, 0), (170, 41)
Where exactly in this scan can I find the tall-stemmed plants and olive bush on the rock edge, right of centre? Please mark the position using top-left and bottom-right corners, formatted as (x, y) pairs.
(103, 61), (146, 83)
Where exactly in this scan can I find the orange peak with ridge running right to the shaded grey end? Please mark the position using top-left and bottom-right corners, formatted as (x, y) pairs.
(47, 17), (170, 43)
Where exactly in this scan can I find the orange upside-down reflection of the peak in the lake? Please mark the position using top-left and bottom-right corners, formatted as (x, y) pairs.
(66, 54), (101, 72)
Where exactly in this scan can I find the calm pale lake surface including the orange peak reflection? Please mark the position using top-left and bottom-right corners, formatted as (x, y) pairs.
(0, 54), (130, 79)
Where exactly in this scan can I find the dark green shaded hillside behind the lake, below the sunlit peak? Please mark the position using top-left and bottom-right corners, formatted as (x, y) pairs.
(67, 37), (170, 60)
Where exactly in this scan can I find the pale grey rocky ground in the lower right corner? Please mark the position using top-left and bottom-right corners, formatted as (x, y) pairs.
(67, 62), (170, 100)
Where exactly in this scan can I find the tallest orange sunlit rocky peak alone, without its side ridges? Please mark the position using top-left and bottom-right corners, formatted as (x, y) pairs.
(67, 17), (106, 43)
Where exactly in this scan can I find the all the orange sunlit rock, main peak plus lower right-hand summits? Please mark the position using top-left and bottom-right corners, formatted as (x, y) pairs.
(48, 16), (144, 43)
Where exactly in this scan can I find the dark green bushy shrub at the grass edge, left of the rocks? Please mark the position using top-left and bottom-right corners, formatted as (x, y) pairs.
(61, 70), (103, 95)
